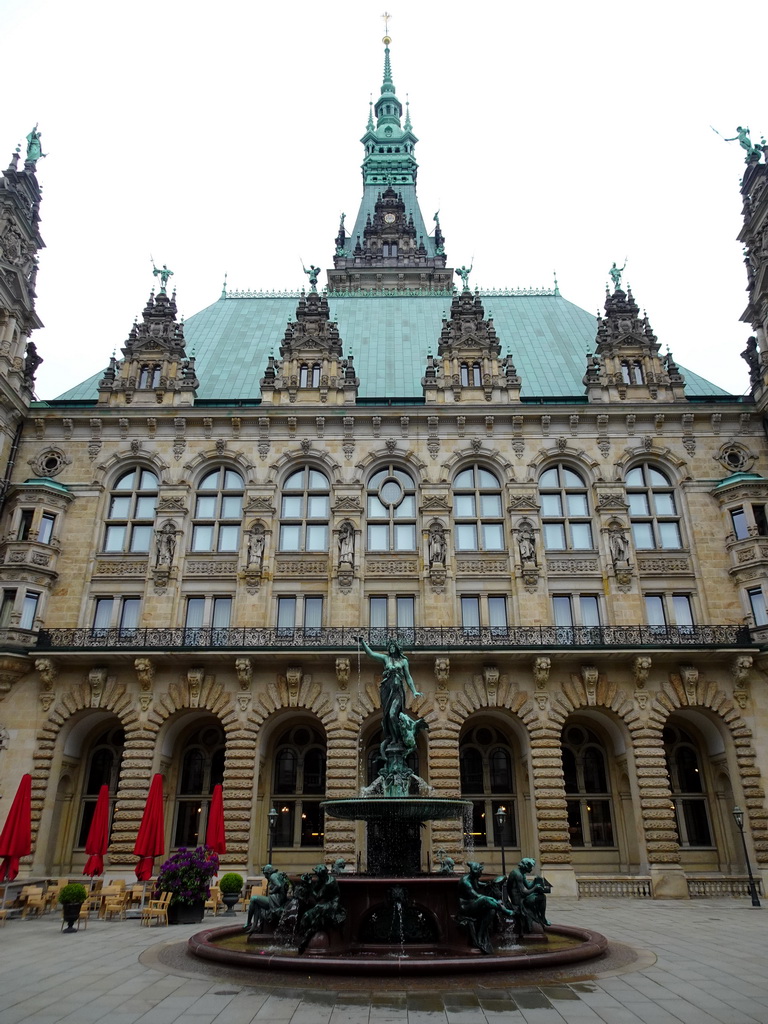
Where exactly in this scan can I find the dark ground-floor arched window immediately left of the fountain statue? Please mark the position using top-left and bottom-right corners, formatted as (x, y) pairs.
(271, 725), (326, 847)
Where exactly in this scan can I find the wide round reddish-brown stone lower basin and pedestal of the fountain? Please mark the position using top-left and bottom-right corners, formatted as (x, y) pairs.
(188, 874), (607, 976)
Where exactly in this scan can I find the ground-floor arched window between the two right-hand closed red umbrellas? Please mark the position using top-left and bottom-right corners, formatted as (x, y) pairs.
(173, 725), (224, 847)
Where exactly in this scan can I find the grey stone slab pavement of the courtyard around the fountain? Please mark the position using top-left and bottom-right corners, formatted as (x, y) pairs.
(0, 898), (768, 1024)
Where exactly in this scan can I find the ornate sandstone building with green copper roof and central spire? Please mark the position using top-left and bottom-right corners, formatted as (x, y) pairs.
(0, 48), (768, 896)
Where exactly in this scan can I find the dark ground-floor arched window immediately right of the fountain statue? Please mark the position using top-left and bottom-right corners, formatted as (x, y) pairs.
(459, 725), (518, 849)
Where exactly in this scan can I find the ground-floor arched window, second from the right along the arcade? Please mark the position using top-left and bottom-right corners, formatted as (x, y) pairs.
(562, 725), (615, 849)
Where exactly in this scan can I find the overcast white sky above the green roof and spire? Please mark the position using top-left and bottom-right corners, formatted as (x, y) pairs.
(0, 0), (768, 398)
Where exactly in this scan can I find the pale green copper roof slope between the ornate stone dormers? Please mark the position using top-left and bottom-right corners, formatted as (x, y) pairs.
(59, 293), (727, 401)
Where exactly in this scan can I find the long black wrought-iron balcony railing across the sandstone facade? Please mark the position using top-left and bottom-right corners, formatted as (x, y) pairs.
(36, 626), (754, 651)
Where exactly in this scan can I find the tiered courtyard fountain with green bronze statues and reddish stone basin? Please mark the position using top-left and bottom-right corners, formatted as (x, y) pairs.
(188, 638), (607, 976)
